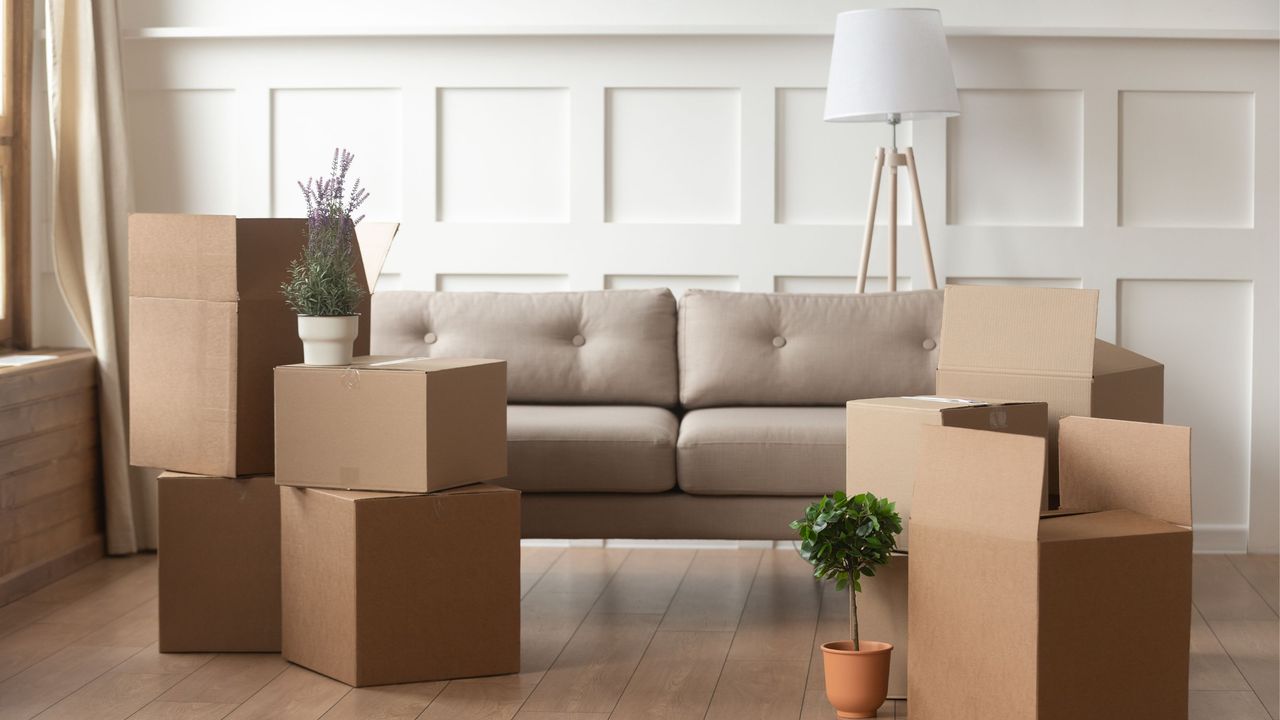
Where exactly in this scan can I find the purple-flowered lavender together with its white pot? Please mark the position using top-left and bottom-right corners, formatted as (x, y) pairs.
(280, 150), (369, 365)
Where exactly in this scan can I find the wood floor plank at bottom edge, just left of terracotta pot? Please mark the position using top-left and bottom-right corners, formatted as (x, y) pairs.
(707, 648), (809, 720)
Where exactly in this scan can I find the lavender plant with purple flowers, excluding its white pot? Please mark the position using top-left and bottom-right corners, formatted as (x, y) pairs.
(280, 149), (369, 316)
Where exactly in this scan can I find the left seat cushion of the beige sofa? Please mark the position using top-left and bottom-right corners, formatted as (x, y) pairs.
(498, 405), (677, 492)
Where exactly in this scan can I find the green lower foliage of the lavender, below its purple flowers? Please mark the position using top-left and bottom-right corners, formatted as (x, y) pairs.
(280, 224), (365, 316)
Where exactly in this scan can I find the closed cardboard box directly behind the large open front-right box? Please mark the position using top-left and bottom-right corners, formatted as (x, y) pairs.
(845, 396), (1048, 551)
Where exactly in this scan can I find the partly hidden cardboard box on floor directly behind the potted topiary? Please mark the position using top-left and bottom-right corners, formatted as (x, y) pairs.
(855, 553), (910, 700)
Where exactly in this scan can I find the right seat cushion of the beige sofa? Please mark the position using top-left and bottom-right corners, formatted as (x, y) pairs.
(676, 407), (845, 496)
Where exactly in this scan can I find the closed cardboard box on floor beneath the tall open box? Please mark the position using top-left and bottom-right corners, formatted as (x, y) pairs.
(157, 473), (280, 652)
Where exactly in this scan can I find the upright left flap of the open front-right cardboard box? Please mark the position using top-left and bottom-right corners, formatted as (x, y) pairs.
(916, 425), (1044, 541)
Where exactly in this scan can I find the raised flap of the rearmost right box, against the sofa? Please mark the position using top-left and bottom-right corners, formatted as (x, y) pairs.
(938, 286), (1098, 378)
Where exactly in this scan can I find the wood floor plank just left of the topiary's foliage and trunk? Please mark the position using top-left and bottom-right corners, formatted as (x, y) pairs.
(728, 550), (822, 662)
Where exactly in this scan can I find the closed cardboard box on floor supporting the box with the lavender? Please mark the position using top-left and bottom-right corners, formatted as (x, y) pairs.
(280, 486), (520, 685)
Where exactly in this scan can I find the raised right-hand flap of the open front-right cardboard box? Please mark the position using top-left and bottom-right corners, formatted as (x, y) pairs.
(1059, 416), (1192, 525)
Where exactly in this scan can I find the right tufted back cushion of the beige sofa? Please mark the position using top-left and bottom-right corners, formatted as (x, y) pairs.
(680, 290), (942, 407)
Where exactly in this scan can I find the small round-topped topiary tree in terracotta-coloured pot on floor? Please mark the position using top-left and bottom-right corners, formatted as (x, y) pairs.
(791, 492), (902, 717)
